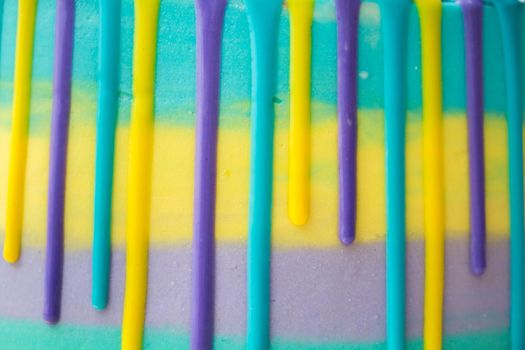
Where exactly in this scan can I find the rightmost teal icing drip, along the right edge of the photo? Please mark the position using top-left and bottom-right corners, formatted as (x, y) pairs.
(494, 0), (525, 350)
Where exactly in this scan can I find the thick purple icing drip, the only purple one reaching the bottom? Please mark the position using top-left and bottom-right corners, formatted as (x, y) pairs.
(191, 0), (227, 350)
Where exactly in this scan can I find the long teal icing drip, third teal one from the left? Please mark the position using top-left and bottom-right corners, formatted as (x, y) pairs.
(380, 0), (411, 349)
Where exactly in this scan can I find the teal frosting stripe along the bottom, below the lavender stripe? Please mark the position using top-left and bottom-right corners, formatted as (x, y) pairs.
(0, 320), (510, 350)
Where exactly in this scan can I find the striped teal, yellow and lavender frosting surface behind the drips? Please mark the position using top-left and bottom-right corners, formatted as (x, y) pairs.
(0, 0), (525, 350)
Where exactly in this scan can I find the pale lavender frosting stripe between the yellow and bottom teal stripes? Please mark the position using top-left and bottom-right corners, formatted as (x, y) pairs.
(0, 240), (509, 342)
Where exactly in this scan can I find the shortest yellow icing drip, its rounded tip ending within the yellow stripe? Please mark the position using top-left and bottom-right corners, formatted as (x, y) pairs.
(288, 0), (314, 225)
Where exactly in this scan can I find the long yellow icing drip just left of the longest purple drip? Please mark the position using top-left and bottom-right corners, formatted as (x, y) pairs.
(122, 0), (160, 350)
